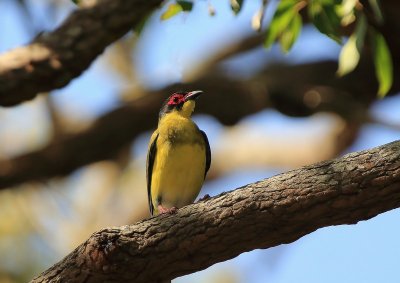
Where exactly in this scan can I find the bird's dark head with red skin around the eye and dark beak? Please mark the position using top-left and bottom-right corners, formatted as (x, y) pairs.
(159, 90), (203, 119)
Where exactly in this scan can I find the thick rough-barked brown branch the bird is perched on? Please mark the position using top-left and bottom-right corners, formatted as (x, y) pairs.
(32, 141), (400, 283)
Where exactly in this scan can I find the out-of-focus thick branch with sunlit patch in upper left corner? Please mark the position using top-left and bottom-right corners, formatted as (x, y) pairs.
(0, 0), (162, 106)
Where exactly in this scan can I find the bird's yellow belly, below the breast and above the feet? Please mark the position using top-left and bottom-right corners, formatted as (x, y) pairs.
(151, 142), (206, 211)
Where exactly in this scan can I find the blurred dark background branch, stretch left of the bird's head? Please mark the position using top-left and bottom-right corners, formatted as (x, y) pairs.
(0, 97), (161, 188)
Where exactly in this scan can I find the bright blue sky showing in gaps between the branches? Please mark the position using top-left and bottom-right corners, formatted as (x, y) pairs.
(0, 0), (400, 283)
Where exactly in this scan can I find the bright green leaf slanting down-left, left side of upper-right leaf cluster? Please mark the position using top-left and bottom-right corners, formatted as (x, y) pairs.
(264, 0), (298, 48)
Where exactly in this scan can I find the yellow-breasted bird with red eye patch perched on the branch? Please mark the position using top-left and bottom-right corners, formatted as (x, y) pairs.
(146, 90), (211, 216)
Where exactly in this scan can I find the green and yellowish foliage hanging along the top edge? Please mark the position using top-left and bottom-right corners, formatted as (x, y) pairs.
(73, 0), (393, 97)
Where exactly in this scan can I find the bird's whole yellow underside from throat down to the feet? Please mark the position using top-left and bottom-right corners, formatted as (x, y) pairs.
(151, 113), (206, 214)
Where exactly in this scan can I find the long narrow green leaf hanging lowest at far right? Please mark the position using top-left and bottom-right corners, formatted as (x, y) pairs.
(371, 29), (393, 98)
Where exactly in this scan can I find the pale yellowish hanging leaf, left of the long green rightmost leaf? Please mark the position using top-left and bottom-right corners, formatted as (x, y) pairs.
(337, 14), (367, 76)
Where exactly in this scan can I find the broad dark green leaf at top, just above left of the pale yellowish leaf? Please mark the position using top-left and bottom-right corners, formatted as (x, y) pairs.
(308, 0), (342, 44)
